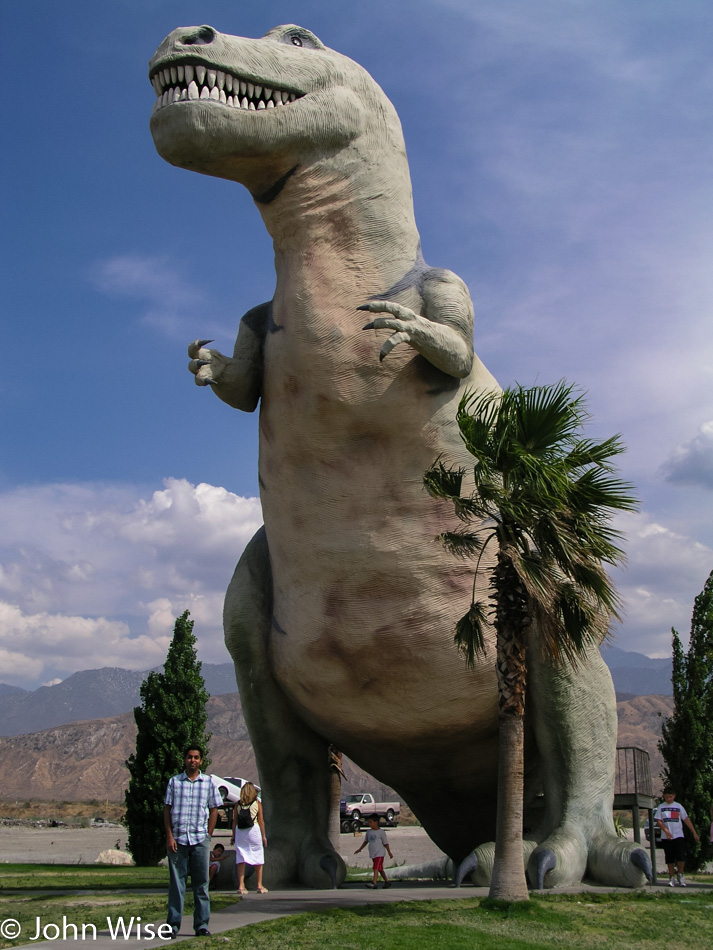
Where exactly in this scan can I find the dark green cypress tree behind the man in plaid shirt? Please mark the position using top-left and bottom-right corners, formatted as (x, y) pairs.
(125, 611), (210, 867)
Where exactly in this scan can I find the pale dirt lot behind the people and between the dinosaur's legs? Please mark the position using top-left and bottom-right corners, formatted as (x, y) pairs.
(0, 825), (442, 867)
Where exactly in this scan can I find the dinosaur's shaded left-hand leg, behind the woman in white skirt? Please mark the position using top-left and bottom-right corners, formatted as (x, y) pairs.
(223, 528), (345, 888)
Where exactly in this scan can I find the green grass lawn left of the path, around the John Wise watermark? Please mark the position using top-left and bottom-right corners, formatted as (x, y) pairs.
(0, 864), (236, 948)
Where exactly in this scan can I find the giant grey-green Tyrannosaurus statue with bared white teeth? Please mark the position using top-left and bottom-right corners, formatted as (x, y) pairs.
(149, 26), (644, 887)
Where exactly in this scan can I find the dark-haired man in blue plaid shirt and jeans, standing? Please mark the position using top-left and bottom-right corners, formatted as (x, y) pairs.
(163, 746), (223, 937)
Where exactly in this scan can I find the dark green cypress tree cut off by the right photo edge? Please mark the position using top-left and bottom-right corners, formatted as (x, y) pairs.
(659, 572), (713, 870)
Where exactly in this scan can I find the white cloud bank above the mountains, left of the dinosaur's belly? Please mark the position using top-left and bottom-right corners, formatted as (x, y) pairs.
(0, 479), (262, 686)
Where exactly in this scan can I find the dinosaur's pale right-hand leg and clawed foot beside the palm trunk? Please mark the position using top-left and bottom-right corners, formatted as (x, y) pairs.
(527, 648), (651, 888)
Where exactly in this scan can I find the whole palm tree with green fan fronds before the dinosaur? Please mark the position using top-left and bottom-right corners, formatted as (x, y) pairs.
(424, 382), (636, 900)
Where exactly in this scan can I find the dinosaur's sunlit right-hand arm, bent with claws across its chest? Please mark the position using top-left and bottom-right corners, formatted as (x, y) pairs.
(359, 270), (473, 379)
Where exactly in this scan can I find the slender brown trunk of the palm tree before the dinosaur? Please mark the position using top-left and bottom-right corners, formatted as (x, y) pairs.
(490, 553), (530, 901)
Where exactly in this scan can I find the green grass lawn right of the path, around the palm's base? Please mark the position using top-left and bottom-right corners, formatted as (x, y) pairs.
(210, 892), (713, 950)
